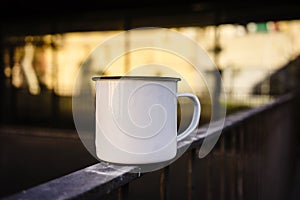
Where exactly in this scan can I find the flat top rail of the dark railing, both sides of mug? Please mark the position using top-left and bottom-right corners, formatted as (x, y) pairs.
(5, 94), (294, 200)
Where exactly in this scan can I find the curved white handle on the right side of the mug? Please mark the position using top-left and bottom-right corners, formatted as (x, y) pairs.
(177, 93), (201, 142)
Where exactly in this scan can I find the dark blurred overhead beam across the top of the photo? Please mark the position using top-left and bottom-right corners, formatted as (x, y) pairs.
(0, 0), (300, 36)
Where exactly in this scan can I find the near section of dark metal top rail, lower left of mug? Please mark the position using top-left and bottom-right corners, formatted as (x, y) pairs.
(6, 163), (139, 200)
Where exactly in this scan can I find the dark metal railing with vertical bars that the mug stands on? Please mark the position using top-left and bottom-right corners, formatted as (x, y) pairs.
(6, 94), (297, 200)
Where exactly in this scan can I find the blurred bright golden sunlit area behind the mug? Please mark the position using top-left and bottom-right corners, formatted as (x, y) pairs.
(4, 21), (300, 99)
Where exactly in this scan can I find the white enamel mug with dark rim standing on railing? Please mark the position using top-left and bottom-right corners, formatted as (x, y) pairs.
(93, 76), (201, 164)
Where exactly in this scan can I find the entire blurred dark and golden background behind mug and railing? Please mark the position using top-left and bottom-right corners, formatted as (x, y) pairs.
(0, 0), (300, 197)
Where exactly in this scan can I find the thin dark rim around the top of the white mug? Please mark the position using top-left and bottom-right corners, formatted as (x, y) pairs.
(92, 76), (181, 82)
